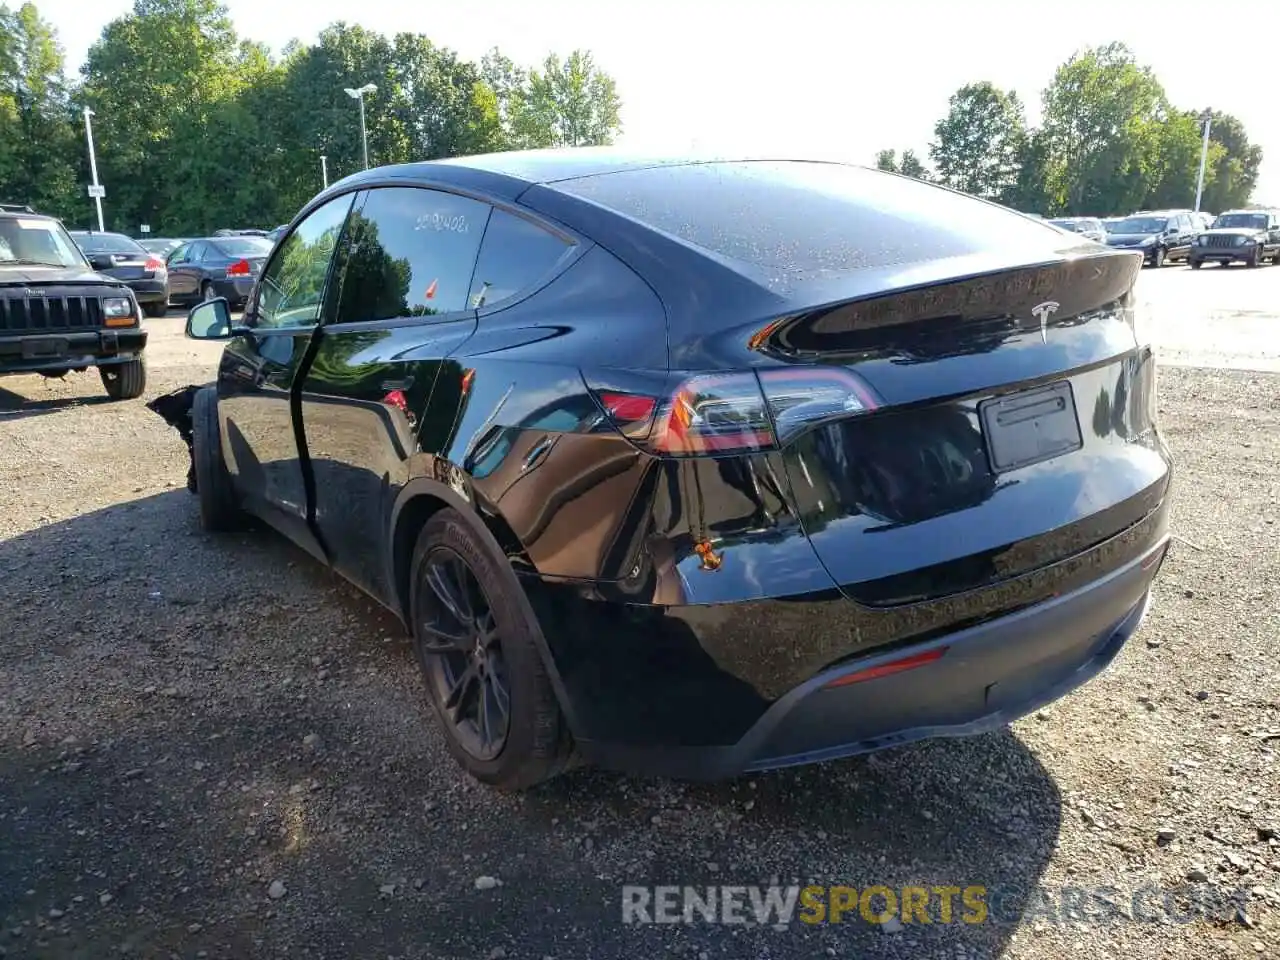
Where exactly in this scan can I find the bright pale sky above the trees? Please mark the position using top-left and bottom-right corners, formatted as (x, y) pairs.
(36, 0), (1280, 206)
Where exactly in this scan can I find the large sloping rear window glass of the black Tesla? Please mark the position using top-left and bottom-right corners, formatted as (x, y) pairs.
(552, 160), (1052, 292)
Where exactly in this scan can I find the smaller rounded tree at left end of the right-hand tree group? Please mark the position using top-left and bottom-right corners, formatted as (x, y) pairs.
(929, 81), (1027, 200)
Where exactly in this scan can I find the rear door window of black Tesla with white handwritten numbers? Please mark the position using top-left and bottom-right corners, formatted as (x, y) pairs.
(337, 187), (492, 324)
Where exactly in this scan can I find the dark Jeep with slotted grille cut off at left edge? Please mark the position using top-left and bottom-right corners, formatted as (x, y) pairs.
(0, 205), (147, 399)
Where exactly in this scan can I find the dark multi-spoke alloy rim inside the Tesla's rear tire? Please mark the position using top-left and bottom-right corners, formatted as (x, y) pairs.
(416, 547), (511, 760)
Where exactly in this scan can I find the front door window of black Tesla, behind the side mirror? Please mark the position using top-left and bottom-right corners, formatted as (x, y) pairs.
(252, 193), (355, 328)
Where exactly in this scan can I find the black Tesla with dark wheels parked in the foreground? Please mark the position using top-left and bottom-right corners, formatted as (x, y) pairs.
(177, 150), (1170, 788)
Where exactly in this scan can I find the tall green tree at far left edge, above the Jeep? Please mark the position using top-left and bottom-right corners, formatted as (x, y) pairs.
(0, 3), (83, 211)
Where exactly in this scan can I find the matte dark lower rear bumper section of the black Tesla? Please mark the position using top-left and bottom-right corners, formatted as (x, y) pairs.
(579, 536), (1169, 780)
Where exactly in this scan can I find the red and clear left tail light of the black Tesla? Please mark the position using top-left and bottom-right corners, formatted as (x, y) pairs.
(593, 366), (877, 457)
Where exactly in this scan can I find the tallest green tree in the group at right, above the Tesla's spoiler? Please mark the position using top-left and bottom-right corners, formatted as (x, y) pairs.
(1043, 44), (1167, 214)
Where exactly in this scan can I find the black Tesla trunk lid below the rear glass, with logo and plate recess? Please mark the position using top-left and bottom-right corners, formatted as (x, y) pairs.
(755, 253), (1169, 605)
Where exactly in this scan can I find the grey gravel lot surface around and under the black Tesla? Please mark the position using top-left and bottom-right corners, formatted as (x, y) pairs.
(0, 268), (1280, 960)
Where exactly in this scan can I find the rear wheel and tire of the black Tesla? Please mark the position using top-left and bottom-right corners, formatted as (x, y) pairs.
(410, 508), (572, 790)
